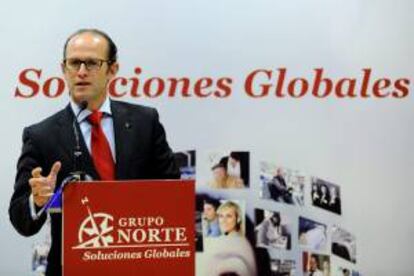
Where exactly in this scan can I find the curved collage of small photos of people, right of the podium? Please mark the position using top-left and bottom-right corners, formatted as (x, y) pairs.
(176, 150), (361, 276)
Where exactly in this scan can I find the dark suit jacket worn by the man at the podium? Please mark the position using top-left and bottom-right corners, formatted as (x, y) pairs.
(9, 101), (179, 276)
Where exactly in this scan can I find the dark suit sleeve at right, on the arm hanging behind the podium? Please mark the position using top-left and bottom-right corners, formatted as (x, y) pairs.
(151, 109), (180, 179)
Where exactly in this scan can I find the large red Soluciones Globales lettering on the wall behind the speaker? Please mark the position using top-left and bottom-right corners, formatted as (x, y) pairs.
(14, 67), (410, 99)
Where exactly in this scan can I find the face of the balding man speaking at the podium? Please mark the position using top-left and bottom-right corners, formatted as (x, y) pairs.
(62, 33), (118, 109)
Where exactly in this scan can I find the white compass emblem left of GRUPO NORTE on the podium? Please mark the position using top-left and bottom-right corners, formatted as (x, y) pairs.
(73, 197), (114, 249)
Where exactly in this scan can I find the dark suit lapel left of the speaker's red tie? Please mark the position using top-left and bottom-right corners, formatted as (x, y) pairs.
(59, 104), (99, 180)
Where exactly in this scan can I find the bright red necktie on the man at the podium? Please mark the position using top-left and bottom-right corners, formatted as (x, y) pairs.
(88, 110), (115, 180)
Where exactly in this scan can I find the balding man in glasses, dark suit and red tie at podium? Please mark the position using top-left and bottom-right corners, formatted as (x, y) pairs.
(9, 29), (179, 276)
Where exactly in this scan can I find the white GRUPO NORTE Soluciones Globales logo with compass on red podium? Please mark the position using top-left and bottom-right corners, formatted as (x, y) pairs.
(72, 197), (191, 261)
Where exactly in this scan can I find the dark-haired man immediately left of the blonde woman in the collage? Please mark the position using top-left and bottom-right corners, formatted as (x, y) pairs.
(203, 198), (221, 238)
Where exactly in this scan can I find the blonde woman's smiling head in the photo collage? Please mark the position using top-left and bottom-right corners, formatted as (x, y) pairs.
(217, 200), (244, 237)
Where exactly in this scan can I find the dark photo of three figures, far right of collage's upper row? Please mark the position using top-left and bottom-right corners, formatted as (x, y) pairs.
(311, 177), (341, 215)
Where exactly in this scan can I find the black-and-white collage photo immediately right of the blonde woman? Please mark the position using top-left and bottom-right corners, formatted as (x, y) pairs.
(255, 209), (291, 249)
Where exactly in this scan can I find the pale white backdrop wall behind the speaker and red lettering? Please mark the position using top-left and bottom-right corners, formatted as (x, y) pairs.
(0, 0), (414, 275)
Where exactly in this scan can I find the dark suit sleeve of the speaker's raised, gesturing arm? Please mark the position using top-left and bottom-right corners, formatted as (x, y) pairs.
(9, 128), (46, 236)
